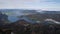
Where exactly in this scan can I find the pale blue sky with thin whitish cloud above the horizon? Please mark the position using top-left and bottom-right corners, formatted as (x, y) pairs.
(0, 0), (60, 11)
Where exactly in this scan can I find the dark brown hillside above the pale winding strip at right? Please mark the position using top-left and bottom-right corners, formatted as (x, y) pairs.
(26, 14), (60, 21)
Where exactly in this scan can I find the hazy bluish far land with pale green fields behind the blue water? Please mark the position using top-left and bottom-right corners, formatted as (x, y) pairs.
(0, 9), (37, 16)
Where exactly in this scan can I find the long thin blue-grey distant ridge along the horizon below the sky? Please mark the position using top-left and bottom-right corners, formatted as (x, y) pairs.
(0, 9), (60, 14)
